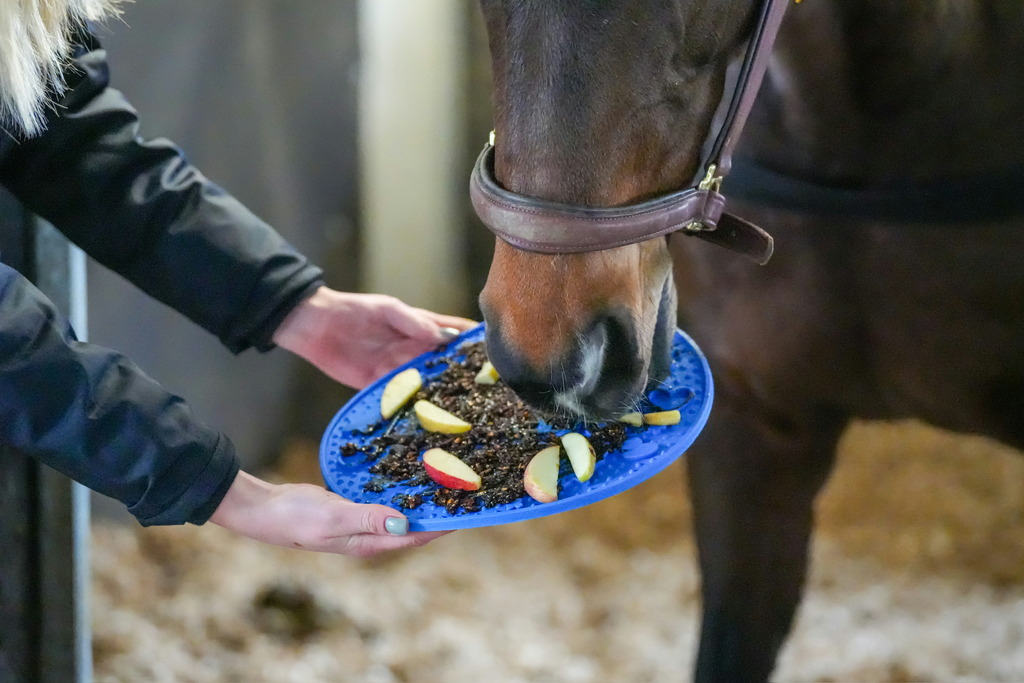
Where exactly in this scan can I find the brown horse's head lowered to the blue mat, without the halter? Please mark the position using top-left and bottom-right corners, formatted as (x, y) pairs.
(480, 0), (758, 419)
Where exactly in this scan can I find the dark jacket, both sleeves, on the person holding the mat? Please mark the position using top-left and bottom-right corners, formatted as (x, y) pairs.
(0, 33), (322, 524)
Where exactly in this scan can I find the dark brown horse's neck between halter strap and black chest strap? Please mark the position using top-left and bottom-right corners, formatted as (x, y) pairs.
(742, 0), (1024, 180)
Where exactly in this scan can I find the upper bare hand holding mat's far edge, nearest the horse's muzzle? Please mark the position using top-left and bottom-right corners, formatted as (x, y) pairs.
(273, 287), (476, 389)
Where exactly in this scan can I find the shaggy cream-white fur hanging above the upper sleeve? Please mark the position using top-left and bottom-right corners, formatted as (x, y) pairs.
(0, 0), (119, 135)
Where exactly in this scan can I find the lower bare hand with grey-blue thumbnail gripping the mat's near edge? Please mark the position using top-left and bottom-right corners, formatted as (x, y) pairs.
(210, 472), (449, 557)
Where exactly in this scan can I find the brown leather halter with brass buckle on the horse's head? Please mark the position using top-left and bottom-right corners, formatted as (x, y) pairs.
(469, 0), (799, 264)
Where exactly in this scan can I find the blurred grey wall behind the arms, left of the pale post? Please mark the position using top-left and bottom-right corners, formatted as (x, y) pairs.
(89, 0), (358, 493)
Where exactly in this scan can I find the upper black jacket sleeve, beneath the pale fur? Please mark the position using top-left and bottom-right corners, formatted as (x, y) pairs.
(0, 26), (322, 352)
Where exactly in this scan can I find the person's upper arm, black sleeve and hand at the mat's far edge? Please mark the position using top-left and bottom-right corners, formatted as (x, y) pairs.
(0, 24), (471, 374)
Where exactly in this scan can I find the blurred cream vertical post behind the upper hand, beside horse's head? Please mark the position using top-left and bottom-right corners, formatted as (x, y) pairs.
(359, 0), (470, 312)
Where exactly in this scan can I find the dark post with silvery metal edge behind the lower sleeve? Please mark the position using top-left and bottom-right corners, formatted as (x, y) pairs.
(0, 189), (92, 683)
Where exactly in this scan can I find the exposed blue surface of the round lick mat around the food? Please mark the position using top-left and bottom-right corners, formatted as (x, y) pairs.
(321, 325), (714, 531)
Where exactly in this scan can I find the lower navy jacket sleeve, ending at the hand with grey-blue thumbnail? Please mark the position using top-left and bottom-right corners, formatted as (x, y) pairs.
(0, 263), (239, 525)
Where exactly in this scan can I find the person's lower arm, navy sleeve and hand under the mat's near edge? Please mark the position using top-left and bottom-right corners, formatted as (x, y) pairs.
(0, 264), (443, 556)
